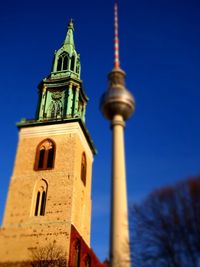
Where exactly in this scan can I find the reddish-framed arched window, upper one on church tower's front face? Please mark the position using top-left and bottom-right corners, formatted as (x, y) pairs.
(35, 139), (55, 170)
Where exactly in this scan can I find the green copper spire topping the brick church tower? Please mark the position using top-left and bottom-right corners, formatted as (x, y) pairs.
(33, 19), (88, 122)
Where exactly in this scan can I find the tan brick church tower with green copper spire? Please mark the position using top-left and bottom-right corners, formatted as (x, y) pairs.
(0, 20), (100, 267)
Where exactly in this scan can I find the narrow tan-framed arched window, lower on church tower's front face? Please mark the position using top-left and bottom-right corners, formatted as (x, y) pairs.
(34, 180), (48, 216)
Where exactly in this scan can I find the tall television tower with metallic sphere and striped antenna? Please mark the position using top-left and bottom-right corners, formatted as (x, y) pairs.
(100, 2), (135, 267)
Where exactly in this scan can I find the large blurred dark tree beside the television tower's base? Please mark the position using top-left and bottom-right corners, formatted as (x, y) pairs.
(131, 177), (200, 267)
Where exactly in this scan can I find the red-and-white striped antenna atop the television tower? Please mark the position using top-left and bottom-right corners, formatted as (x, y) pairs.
(114, 0), (120, 69)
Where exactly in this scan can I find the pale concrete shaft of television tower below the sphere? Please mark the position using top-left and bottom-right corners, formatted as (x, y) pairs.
(110, 115), (130, 267)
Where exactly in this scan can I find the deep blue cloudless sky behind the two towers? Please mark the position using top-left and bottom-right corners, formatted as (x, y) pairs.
(0, 0), (200, 264)
